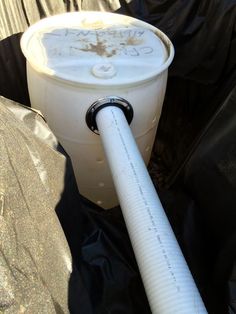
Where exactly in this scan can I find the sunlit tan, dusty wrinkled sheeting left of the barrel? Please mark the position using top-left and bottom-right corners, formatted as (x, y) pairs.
(0, 97), (72, 313)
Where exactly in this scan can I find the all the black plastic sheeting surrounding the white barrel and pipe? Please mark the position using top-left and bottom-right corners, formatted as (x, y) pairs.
(0, 0), (236, 314)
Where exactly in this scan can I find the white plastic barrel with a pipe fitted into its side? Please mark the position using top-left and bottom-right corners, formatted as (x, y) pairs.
(21, 12), (174, 208)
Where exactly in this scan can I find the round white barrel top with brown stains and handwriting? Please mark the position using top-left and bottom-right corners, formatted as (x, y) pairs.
(21, 12), (171, 86)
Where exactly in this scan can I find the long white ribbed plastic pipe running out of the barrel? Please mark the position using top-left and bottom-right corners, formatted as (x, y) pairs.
(96, 106), (207, 314)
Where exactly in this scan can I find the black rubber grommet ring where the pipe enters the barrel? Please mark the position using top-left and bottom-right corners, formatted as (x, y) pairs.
(85, 96), (134, 134)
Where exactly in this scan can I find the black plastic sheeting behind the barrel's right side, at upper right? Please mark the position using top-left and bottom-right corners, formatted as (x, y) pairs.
(118, 0), (236, 185)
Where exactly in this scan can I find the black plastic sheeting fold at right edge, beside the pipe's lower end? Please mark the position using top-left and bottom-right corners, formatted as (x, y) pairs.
(183, 87), (236, 313)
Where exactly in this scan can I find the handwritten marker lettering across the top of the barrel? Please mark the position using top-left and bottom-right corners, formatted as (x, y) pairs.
(41, 28), (155, 58)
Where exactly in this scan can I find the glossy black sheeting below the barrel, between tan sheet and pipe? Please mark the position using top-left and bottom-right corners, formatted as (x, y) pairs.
(56, 147), (150, 314)
